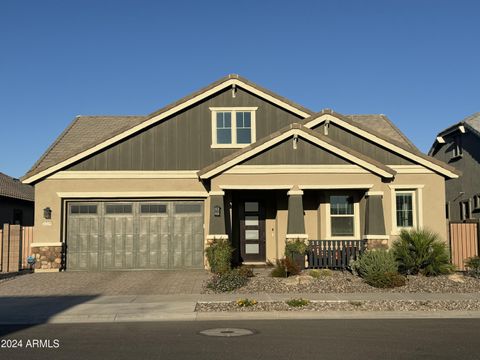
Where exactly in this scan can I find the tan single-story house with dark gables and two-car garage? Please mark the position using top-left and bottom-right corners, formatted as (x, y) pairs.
(23, 75), (458, 270)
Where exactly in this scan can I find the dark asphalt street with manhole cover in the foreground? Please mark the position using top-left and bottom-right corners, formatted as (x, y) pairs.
(0, 319), (480, 360)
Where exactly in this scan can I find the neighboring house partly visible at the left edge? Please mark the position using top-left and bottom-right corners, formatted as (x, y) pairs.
(0, 173), (35, 227)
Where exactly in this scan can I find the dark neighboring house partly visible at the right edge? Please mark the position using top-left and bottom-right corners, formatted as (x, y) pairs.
(429, 112), (480, 221)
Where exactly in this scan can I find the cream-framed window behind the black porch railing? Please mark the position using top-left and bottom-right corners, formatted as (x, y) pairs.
(329, 195), (355, 237)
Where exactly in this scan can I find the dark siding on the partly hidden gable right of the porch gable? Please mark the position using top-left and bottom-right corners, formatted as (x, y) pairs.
(314, 123), (414, 165)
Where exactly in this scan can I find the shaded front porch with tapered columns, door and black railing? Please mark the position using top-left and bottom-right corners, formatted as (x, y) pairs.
(208, 186), (388, 268)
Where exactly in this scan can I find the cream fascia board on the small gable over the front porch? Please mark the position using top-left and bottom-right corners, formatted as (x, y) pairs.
(200, 129), (394, 179)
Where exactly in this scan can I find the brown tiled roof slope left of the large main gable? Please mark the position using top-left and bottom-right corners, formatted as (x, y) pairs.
(24, 116), (145, 178)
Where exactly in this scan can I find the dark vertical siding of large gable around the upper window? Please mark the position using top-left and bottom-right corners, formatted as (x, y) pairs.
(68, 87), (301, 171)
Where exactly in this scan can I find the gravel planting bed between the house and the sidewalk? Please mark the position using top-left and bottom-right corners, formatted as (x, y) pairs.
(203, 269), (480, 294)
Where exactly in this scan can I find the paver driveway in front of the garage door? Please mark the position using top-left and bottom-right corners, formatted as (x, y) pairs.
(0, 270), (209, 296)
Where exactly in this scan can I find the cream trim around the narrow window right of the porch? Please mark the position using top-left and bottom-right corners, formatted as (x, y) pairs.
(390, 185), (423, 235)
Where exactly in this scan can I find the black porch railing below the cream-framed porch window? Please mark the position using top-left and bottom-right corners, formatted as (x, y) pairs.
(307, 240), (366, 269)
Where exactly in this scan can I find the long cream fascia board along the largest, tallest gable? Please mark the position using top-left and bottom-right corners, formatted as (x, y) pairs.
(22, 79), (310, 184)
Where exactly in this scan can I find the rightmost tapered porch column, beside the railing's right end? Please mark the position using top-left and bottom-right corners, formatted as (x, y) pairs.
(363, 191), (388, 249)
